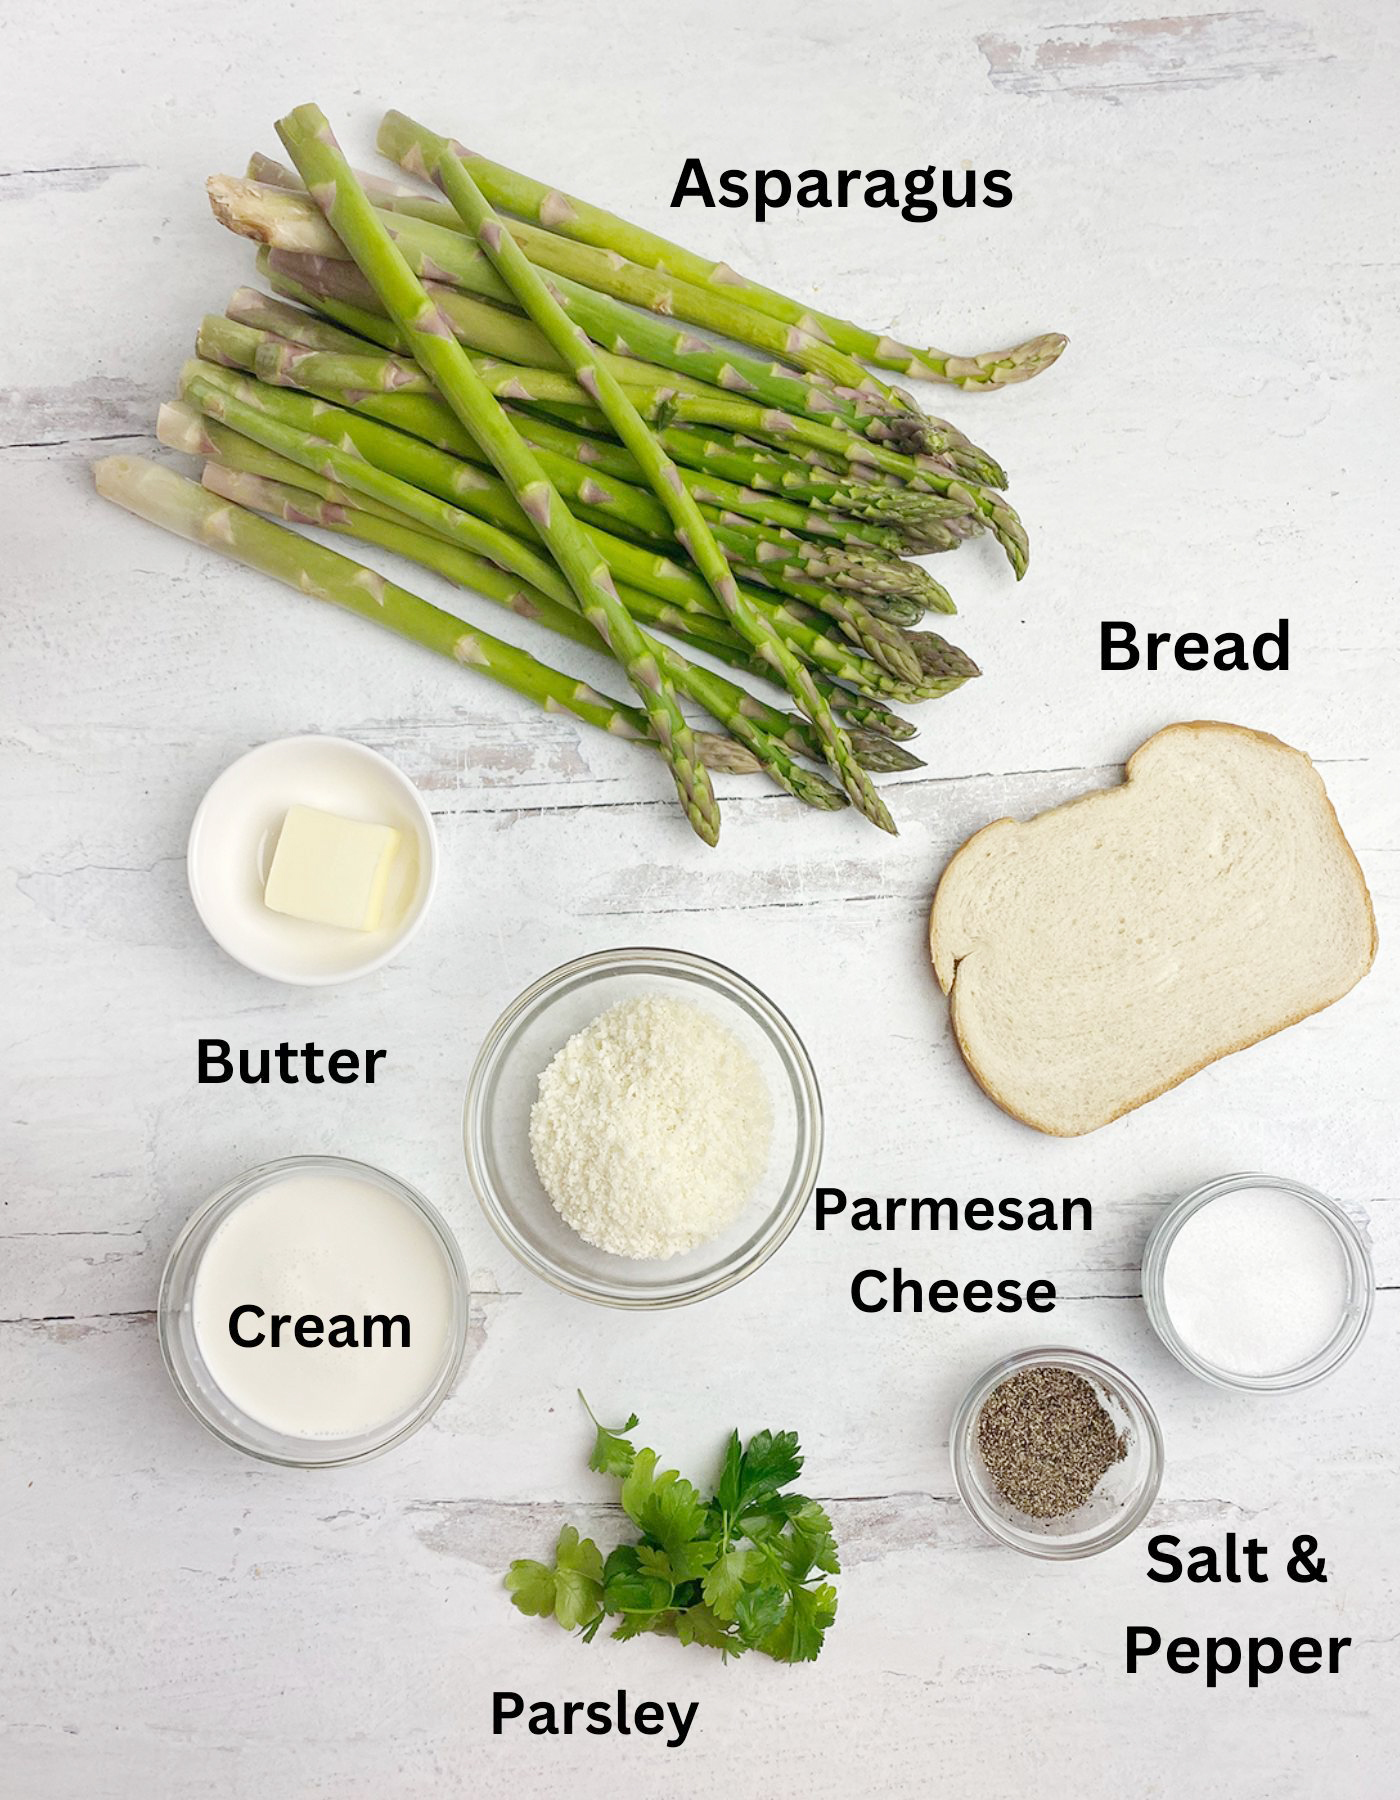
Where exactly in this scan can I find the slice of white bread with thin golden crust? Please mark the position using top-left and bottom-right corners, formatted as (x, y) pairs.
(929, 722), (1377, 1138)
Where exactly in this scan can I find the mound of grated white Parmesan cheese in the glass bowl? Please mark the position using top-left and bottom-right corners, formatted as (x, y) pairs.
(529, 994), (772, 1260)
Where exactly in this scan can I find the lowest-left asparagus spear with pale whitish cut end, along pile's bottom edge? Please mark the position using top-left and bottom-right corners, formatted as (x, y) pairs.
(94, 455), (756, 774)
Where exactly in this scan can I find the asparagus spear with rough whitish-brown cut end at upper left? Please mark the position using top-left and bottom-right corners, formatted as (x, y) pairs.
(207, 179), (938, 448)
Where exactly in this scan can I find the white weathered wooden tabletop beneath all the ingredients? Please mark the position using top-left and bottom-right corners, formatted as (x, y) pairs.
(0, 0), (1400, 1800)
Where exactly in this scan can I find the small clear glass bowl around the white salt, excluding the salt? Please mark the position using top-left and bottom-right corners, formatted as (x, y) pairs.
(1143, 1175), (1375, 1393)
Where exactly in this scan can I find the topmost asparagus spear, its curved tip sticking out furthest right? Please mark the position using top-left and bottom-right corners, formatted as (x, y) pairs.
(365, 112), (1067, 387)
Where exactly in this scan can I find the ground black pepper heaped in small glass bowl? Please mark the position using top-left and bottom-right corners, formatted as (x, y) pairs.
(977, 1364), (1126, 1519)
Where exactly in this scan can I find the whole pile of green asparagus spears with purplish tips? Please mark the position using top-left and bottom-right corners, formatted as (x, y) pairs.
(97, 106), (1063, 844)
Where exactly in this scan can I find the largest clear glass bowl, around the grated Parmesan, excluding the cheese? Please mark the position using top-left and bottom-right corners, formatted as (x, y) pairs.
(462, 949), (822, 1309)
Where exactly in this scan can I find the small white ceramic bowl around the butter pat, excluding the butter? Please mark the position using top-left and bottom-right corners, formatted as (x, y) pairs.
(187, 736), (437, 986)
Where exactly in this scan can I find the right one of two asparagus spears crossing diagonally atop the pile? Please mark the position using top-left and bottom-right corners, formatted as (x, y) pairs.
(390, 116), (896, 833)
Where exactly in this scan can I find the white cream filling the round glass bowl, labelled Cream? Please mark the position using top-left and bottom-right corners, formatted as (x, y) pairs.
(191, 1170), (452, 1438)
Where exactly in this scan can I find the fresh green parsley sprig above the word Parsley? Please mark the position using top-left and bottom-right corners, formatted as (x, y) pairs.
(506, 1395), (840, 1663)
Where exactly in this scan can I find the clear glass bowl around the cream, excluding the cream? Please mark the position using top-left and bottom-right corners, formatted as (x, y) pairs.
(157, 1156), (470, 1469)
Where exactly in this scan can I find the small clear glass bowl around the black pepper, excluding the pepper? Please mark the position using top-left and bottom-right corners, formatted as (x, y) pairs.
(948, 1346), (1162, 1562)
